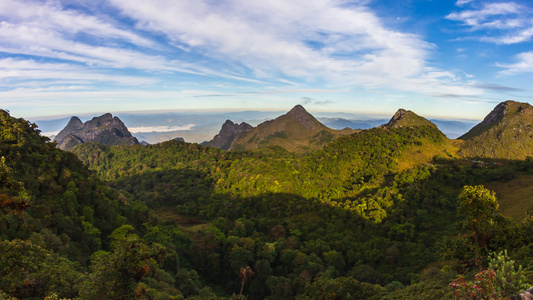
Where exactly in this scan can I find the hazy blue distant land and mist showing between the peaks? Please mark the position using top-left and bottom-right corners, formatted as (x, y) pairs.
(31, 111), (477, 144)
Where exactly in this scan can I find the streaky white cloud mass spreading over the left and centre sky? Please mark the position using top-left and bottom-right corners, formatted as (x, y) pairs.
(0, 0), (484, 110)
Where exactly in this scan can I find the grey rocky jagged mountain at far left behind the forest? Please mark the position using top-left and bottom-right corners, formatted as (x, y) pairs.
(55, 113), (139, 150)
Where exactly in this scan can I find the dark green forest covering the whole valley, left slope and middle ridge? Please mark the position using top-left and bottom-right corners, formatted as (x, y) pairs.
(0, 104), (533, 299)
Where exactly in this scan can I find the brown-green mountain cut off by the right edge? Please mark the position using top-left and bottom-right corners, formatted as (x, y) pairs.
(459, 101), (533, 159)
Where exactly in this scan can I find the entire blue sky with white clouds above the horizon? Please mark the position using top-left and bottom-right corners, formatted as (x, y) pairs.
(0, 0), (533, 119)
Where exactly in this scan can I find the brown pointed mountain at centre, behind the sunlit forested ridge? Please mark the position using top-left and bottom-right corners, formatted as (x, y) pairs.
(229, 105), (354, 152)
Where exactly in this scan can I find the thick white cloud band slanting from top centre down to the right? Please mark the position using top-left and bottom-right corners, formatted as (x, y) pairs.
(111, 0), (478, 96)
